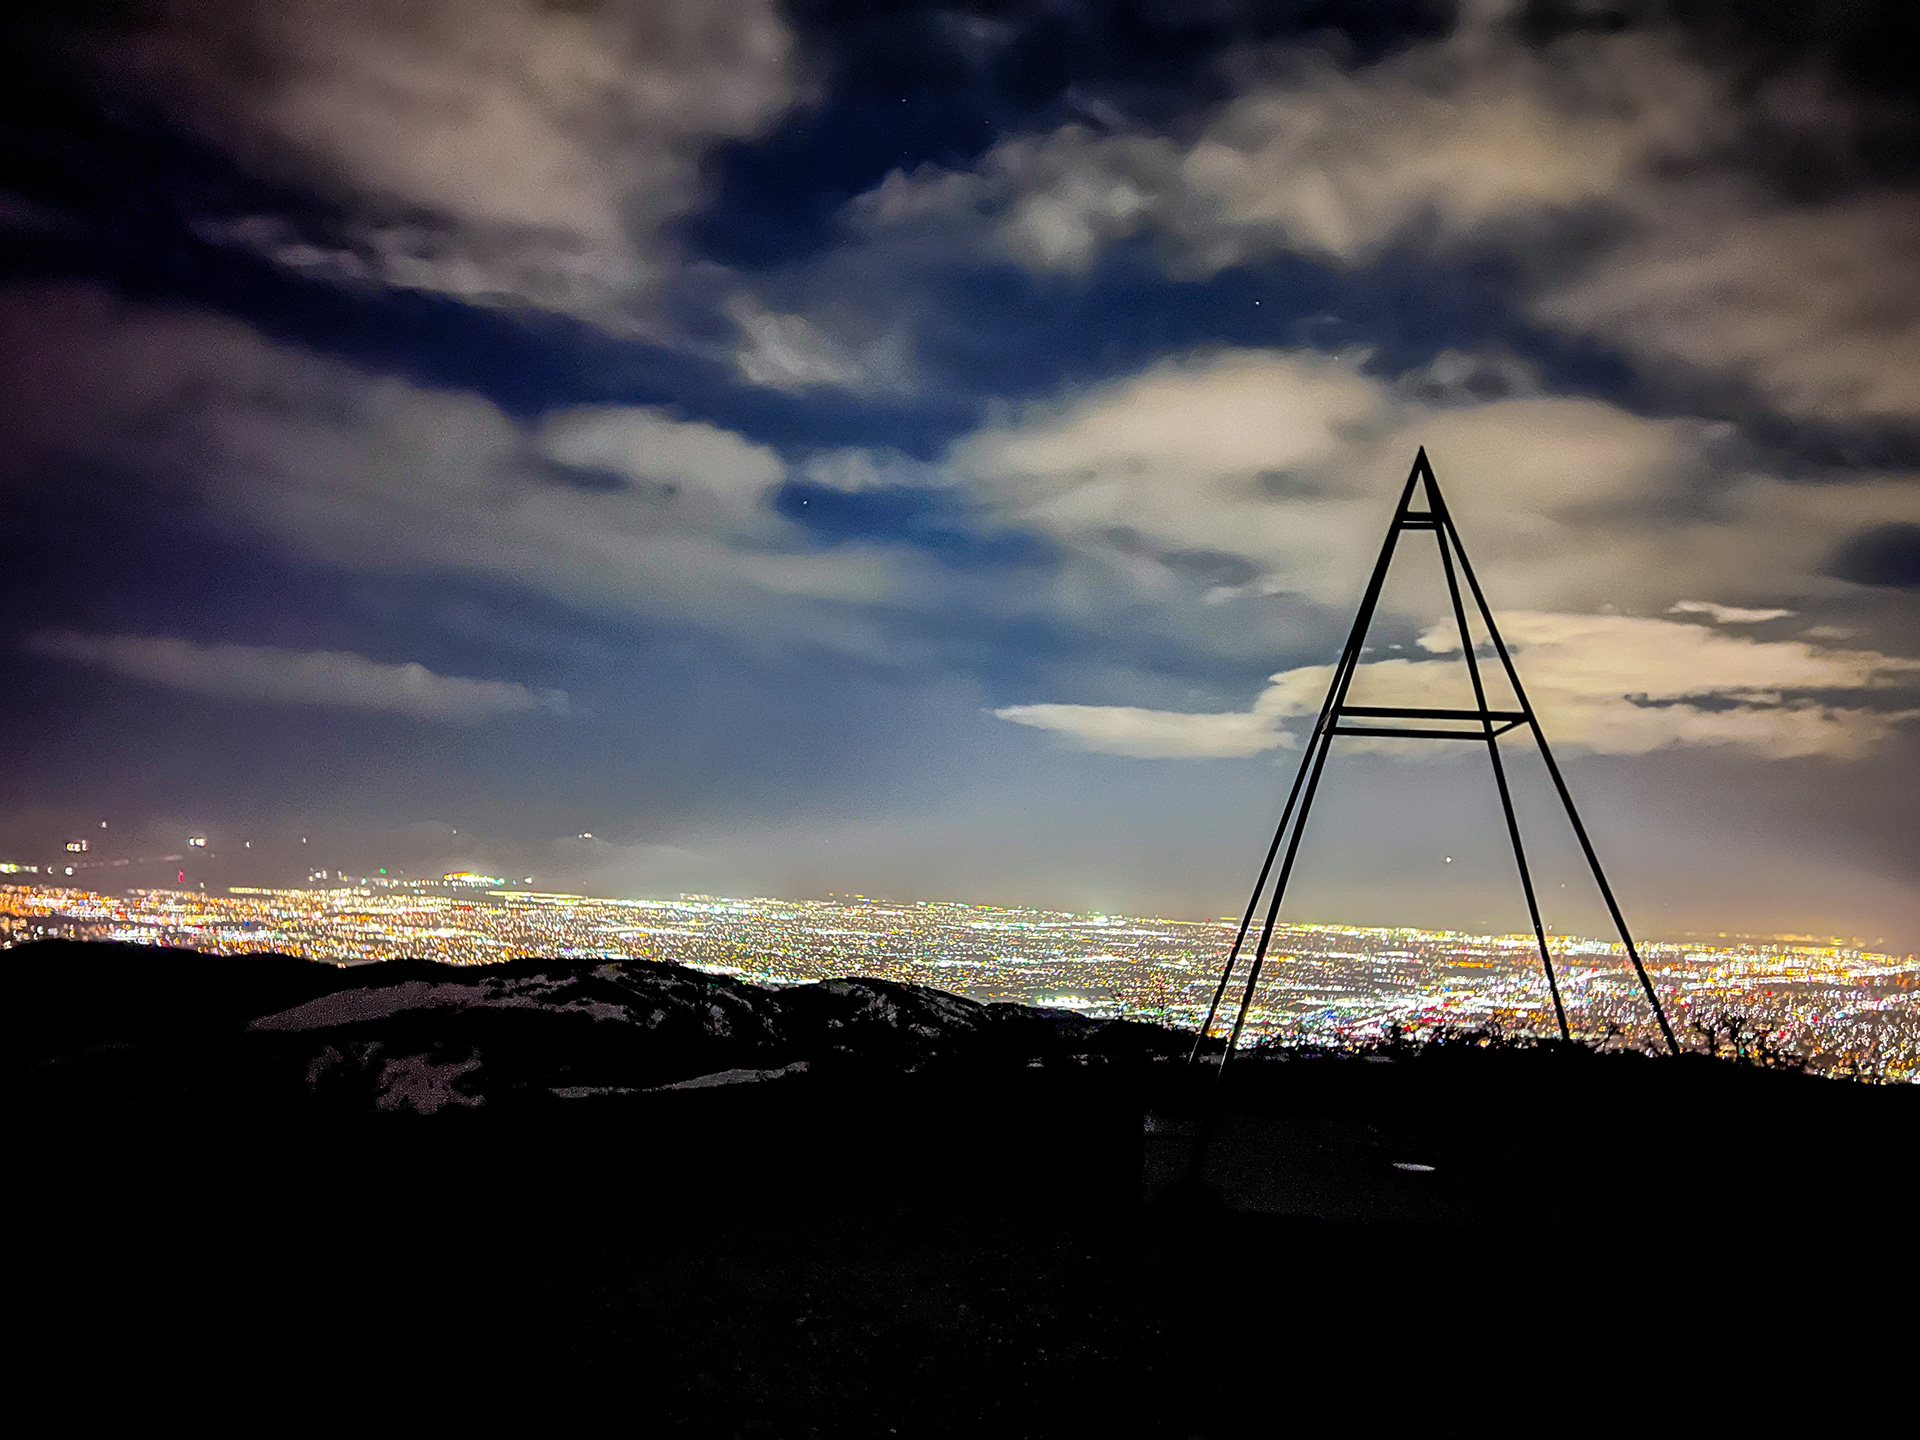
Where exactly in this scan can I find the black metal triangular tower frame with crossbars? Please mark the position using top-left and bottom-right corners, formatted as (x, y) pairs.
(1190, 445), (1680, 1066)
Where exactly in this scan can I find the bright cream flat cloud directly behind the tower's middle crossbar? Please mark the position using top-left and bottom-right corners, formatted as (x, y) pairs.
(995, 612), (1920, 760)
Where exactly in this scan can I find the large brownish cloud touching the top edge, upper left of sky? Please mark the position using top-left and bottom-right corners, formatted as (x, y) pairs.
(96, 0), (806, 309)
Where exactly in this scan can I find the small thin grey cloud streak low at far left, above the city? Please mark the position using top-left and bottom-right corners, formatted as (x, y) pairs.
(27, 632), (568, 722)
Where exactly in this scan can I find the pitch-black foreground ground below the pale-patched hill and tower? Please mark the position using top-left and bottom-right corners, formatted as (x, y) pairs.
(4, 940), (1920, 1436)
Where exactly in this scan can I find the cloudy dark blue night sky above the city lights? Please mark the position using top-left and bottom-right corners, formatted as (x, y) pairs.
(0, 0), (1920, 948)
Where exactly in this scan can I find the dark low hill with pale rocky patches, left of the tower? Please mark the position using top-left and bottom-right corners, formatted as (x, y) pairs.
(0, 941), (1185, 1114)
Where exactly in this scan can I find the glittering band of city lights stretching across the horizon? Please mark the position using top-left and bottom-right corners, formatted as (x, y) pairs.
(0, 868), (1920, 1079)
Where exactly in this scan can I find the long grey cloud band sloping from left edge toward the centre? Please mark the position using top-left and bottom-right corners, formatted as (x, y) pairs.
(0, 286), (912, 651)
